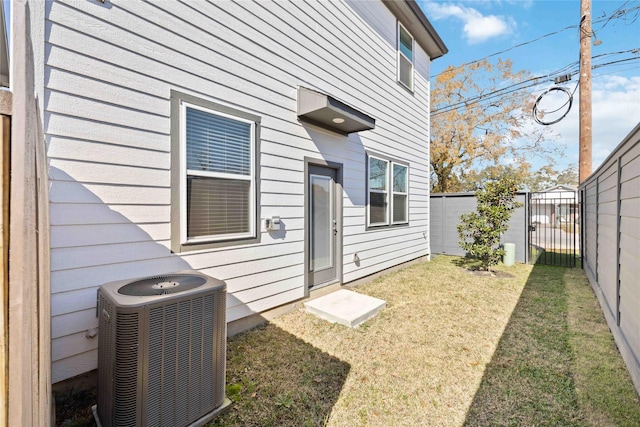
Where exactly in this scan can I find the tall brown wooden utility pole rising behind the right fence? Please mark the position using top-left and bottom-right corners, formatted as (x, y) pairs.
(578, 0), (593, 183)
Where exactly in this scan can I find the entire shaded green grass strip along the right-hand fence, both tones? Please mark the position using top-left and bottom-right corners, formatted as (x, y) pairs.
(464, 265), (640, 426)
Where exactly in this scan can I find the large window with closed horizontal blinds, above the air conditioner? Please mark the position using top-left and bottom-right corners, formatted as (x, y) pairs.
(181, 103), (256, 244)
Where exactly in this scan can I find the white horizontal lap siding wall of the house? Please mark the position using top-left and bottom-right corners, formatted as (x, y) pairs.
(44, 0), (429, 382)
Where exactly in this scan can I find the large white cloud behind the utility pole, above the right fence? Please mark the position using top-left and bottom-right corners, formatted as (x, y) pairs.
(552, 75), (640, 170)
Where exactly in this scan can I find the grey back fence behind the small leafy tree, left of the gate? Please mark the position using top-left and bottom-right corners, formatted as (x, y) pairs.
(429, 193), (529, 263)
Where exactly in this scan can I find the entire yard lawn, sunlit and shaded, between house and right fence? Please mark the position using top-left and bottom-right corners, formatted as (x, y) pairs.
(214, 256), (640, 426)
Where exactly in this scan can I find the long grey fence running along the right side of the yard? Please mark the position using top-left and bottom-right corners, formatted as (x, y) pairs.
(579, 124), (640, 393)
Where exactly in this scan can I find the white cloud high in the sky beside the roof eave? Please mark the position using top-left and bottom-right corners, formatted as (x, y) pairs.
(423, 2), (516, 44)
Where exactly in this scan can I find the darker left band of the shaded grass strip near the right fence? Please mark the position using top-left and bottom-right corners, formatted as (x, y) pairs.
(465, 265), (580, 426)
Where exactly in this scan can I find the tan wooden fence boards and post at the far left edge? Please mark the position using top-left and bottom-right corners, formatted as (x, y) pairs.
(0, 0), (52, 427)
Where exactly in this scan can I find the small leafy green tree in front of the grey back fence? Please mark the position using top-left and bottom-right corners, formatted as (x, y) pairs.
(458, 177), (522, 271)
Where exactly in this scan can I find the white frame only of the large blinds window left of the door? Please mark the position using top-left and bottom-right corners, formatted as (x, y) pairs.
(180, 101), (256, 245)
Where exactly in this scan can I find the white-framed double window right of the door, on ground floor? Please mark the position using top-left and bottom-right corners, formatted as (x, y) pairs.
(367, 156), (409, 227)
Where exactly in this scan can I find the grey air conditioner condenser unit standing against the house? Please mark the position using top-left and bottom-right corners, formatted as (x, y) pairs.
(96, 271), (230, 427)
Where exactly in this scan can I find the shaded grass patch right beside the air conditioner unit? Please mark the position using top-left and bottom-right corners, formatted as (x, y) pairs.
(211, 324), (350, 426)
